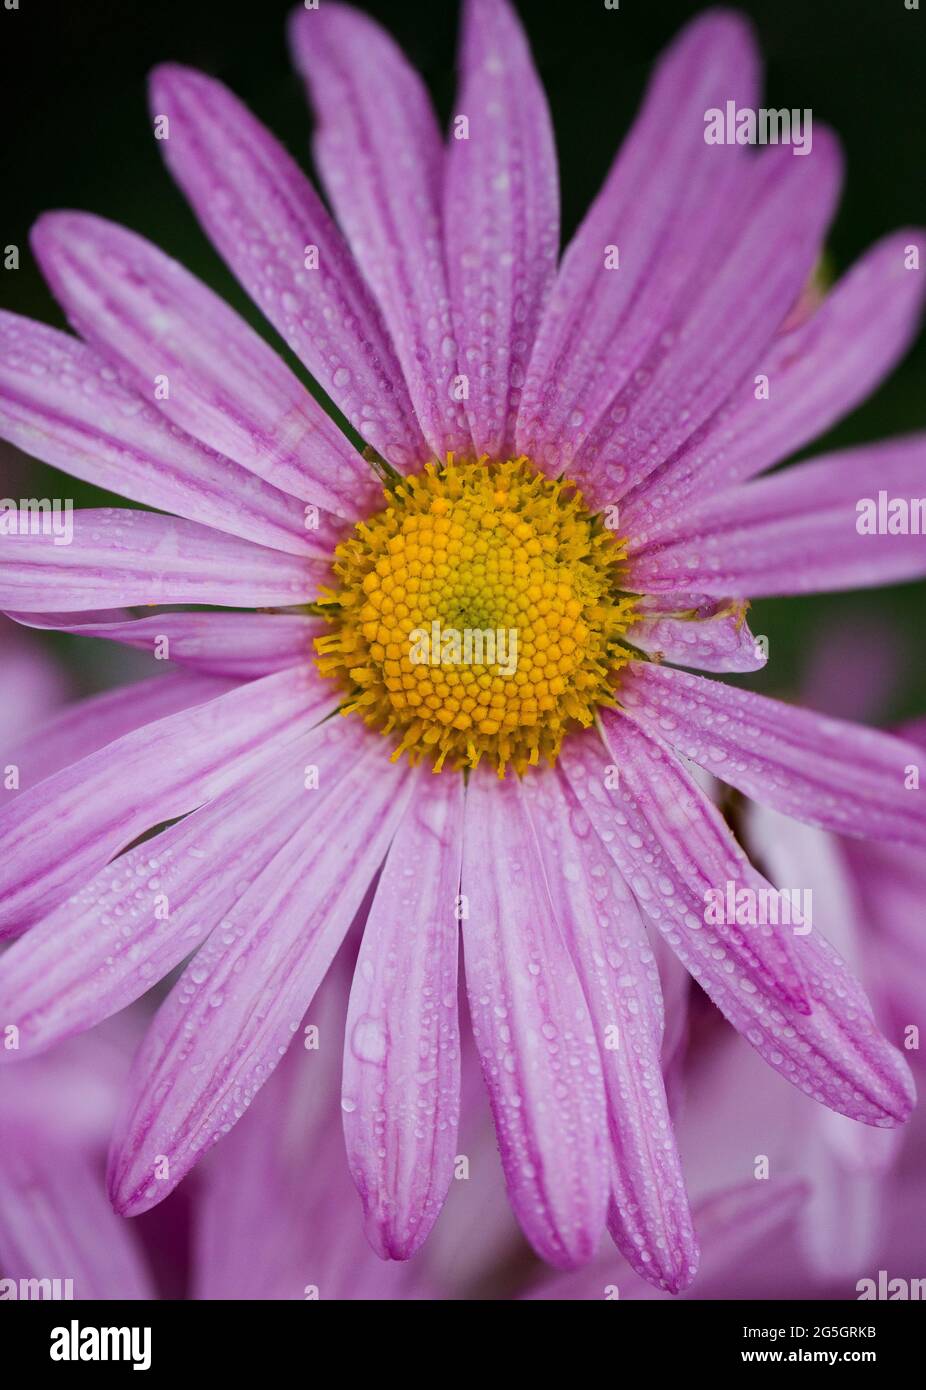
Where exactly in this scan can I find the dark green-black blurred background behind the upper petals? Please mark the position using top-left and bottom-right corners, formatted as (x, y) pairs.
(0, 0), (926, 717)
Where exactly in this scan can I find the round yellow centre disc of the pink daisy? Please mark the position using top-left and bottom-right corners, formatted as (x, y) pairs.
(316, 457), (634, 776)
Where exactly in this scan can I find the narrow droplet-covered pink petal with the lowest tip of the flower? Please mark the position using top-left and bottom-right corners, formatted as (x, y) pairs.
(523, 774), (698, 1293)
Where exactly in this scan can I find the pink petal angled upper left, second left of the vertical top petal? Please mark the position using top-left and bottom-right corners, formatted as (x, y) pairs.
(150, 64), (427, 473)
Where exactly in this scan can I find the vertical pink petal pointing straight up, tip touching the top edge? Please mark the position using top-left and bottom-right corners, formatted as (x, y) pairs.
(444, 0), (559, 459)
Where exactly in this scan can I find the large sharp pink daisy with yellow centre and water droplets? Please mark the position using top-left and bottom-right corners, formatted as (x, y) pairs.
(0, 0), (926, 1290)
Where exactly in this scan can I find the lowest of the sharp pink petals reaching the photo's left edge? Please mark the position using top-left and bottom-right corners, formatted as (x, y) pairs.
(0, 720), (346, 1061)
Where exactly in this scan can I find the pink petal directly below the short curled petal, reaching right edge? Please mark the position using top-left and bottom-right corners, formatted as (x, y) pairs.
(617, 662), (926, 847)
